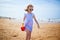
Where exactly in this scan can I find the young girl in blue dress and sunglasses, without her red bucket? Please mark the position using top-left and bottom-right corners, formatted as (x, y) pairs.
(23, 4), (39, 40)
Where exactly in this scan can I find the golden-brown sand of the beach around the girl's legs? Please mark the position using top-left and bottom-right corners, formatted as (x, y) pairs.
(0, 18), (60, 40)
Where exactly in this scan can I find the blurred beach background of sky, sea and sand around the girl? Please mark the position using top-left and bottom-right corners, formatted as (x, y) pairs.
(0, 0), (60, 40)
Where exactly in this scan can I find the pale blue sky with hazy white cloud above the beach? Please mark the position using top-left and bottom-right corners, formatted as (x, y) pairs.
(0, 0), (60, 20)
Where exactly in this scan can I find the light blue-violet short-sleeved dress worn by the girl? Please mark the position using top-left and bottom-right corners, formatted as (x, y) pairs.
(24, 13), (34, 31)
